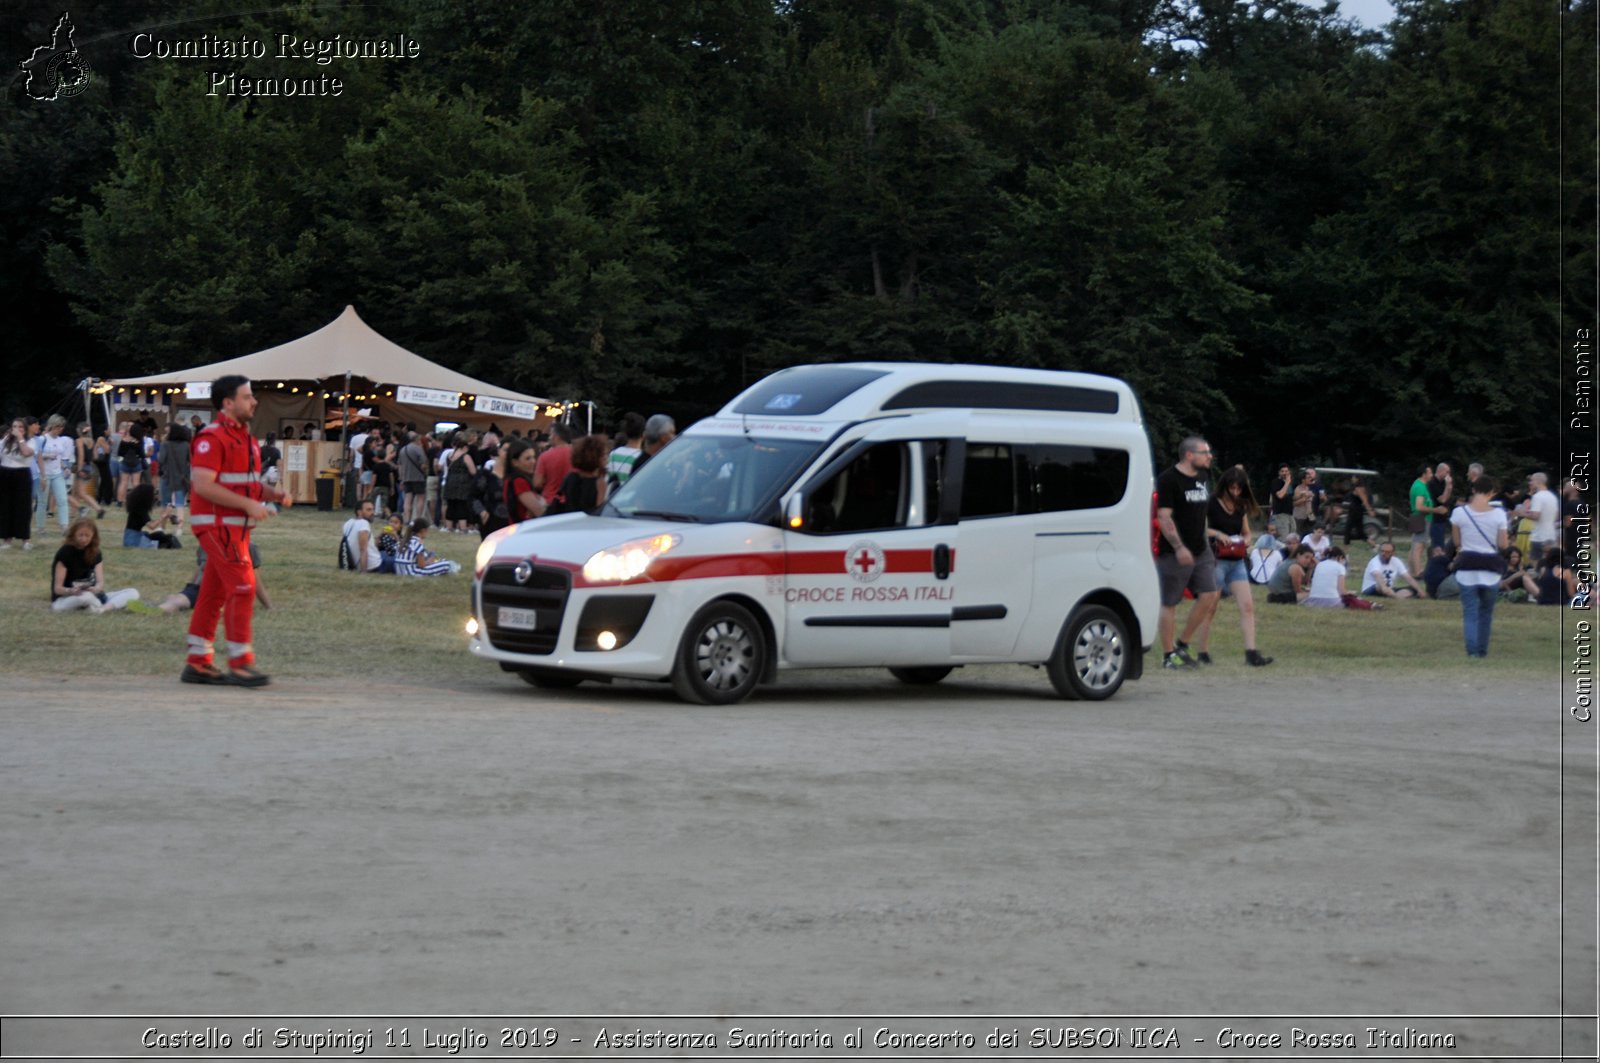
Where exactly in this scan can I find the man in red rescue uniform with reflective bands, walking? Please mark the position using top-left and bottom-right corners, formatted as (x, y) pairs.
(179, 376), (294, 687)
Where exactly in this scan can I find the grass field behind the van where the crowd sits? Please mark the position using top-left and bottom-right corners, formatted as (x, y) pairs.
(0, 507), (1571, 690)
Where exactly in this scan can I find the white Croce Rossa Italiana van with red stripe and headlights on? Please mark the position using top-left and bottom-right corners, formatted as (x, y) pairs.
(469, 362), (1158, 704)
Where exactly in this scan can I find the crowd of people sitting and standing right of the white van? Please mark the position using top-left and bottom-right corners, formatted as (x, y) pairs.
(1155, 437), (1589, 668)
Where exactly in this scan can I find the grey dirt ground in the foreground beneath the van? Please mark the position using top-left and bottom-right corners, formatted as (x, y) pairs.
(0, 668), (1595, 1057)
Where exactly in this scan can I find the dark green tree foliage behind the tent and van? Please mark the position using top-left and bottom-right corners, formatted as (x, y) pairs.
(9, 0), (1574, 489)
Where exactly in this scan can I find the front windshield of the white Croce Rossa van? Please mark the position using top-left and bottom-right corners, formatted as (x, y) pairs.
(606, 435), (822, 523)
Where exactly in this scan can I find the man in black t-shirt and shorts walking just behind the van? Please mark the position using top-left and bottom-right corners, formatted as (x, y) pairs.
(1155, 435), (1221, 668)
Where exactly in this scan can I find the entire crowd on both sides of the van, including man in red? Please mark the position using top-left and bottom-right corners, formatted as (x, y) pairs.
(9, 385), (1587, 675)
